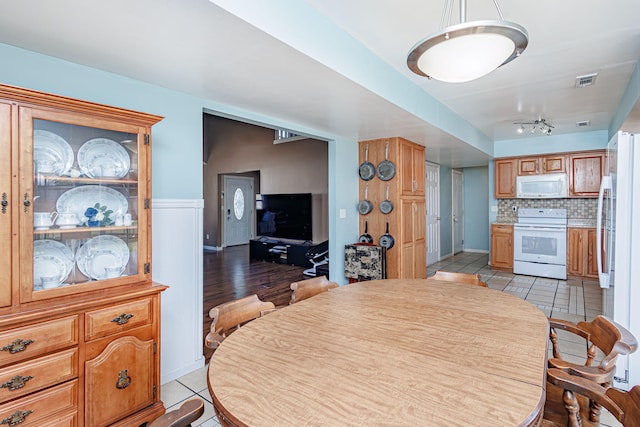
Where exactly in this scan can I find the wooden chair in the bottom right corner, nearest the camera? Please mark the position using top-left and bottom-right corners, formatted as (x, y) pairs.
(542, 368), (640, 427)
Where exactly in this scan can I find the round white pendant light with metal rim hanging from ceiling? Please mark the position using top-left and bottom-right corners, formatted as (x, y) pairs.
(407, 0), (529, 83)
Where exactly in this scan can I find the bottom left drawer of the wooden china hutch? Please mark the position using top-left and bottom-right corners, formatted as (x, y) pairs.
(0, 380), (78, 427)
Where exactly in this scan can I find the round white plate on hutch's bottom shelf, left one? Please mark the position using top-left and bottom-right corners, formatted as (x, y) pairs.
(33, 239), (73, 286)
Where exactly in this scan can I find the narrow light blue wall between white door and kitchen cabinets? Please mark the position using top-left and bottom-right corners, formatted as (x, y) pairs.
(463, 166), (489, 251)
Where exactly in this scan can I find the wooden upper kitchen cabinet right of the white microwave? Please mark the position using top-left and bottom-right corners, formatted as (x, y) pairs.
(569, 151), (606, 197)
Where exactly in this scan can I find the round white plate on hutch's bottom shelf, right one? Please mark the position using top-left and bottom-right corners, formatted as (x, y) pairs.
(76, 234), (129, 280)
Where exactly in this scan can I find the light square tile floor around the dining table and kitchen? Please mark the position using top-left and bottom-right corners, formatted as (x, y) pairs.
(162, 252), (621, 427)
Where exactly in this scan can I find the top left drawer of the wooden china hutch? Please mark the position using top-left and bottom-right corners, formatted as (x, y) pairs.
(0, 316), (78, 366)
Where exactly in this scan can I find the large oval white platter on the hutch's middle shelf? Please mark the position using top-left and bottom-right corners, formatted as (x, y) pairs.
(56, 185), (129, 221)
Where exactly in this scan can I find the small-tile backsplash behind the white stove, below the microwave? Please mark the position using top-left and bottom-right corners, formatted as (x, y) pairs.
(498, 199), (598, 223)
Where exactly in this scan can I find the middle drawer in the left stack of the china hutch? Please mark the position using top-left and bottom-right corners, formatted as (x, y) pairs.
(0, 348), (78, 402)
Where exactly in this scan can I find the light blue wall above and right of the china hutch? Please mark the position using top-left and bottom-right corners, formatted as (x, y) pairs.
(0, 44), (202, 199)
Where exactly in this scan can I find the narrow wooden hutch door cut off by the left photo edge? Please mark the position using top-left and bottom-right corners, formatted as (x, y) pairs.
(0, 102), (13, 307)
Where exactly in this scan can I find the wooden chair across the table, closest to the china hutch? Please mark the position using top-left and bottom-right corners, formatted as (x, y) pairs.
(204, 294), (276, 350)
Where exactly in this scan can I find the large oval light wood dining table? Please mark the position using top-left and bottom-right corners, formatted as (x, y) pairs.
(208, 279), (549, 427)
